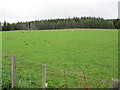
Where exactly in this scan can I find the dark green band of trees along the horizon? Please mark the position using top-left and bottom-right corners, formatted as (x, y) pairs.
(0, 17), (120, 31)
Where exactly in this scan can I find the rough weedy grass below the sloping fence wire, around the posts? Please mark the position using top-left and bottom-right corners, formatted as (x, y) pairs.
(0, 53), (116, 88)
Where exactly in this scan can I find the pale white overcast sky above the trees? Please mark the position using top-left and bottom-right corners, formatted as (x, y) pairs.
(0, 0), (119, 23)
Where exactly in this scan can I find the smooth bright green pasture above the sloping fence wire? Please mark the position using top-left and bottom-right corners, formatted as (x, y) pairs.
(3, 30), (118, 88)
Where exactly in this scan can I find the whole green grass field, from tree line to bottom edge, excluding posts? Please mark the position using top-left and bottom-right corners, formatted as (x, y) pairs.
(2, 30), (118, 88)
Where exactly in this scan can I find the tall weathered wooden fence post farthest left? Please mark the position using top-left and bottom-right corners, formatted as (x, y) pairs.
(11, 56), (16, 88)
